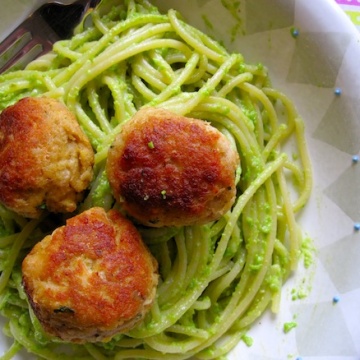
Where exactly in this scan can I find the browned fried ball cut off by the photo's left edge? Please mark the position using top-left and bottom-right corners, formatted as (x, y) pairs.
(0, 97), (94, 218)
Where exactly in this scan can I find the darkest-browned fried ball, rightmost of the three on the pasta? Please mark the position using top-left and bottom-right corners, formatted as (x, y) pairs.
(107, 108), (239, 227)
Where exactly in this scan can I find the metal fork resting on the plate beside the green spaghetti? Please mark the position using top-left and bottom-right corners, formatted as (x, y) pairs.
(0, 0), (101, 73)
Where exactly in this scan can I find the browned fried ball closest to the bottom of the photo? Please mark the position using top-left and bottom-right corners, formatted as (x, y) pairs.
(22, 207), (158, 343)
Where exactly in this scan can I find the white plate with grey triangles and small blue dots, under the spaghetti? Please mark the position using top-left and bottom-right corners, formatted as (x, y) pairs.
(0, 0), (360, 360)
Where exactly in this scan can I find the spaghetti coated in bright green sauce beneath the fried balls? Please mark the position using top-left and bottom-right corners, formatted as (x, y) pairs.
(0, 0), (312, 360)
